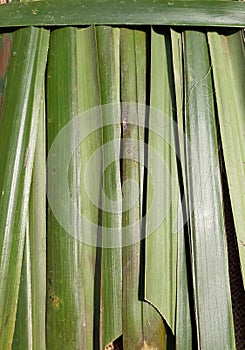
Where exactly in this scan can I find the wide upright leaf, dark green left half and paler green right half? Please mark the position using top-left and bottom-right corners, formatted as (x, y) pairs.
(47, 27), (101, 349)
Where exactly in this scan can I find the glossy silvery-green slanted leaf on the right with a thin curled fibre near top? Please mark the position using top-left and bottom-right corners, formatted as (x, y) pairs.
(184, 31), (235, 350)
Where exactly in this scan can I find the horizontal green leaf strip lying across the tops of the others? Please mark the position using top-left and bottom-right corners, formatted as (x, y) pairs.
(0, 0), (245, 28)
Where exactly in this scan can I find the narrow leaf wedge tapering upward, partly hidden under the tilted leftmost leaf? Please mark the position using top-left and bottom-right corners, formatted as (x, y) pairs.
(13, 85), (46, 350)
